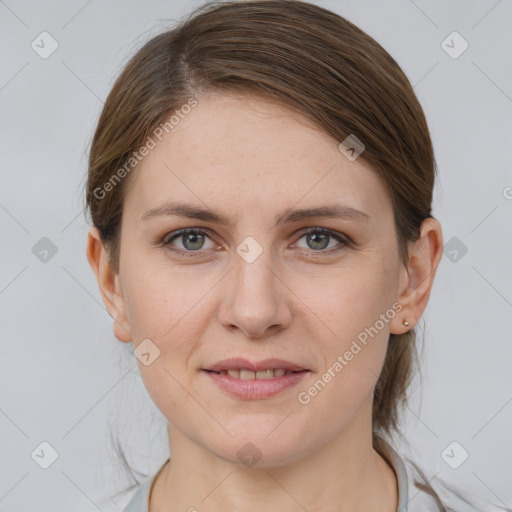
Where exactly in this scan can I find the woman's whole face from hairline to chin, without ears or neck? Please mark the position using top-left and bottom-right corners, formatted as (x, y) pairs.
(111, 94), (405, 466)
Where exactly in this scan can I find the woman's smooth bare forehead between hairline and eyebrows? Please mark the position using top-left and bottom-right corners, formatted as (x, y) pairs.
(125, 94), (391, 222)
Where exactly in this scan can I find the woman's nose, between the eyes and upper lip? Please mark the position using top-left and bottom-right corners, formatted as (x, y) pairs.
(219, 245), (293, 338)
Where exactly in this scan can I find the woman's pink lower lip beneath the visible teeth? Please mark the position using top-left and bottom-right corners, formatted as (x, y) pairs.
(203, 370), (309, 399)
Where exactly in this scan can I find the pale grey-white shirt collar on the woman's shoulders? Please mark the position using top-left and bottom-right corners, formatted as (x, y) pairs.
(123, 441), (512, 512)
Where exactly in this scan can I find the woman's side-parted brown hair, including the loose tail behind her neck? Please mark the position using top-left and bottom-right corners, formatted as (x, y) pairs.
(86, 0), (437, 488)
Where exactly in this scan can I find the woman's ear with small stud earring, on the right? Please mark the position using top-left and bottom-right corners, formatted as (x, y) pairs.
(390, 217), (443, 334)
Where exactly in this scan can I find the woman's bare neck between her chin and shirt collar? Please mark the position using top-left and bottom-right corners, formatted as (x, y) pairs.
(149, 406), (398, 512)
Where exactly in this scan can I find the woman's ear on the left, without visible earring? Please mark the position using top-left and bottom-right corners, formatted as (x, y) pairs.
(87, 227), (132, 343)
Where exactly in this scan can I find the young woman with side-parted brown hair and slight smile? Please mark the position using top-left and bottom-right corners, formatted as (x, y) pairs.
(87, 0), (508, 512)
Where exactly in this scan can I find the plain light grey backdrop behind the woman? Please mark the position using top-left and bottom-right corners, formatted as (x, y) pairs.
(0, 0), (512, 512)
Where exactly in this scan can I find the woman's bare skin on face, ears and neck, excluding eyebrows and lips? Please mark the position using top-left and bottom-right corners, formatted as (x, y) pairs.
(87, 93), (442, 512)
